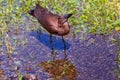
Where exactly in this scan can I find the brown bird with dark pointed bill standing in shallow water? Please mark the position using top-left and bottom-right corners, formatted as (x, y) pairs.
(29, 4), (72, 56)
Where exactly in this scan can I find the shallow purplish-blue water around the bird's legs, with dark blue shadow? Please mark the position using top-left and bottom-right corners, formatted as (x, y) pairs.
(0, 30), (118, 80)
